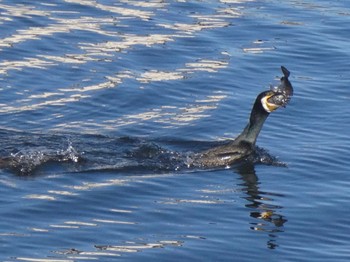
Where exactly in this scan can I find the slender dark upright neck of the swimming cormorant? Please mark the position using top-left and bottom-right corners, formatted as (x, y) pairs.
(234, 99), (269, 145)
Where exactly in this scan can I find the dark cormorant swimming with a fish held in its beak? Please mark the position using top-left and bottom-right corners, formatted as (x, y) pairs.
(191, 66), (293, 167)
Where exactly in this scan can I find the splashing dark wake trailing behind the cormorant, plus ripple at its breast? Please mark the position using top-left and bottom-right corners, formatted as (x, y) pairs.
(0, 131), (285, 176)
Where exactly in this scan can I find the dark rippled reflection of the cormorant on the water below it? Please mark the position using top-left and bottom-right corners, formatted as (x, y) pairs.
(237, 163), (287, 249)
